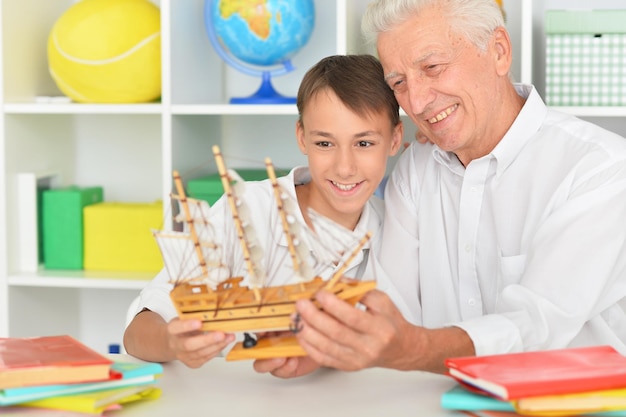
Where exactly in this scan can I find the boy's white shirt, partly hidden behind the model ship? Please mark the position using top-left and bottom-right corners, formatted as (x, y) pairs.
(133, 167), (415, 323)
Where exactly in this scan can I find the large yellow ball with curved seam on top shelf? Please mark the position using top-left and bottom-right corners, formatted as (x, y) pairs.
(48, 0), (161, 103)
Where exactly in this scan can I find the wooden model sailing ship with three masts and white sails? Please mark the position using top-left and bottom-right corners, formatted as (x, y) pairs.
(155, 146), (376, 360)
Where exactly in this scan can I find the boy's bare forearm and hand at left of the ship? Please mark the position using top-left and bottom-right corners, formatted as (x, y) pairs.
(124, 309), (235, 368)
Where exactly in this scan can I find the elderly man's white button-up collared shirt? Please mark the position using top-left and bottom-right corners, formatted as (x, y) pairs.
(379, 85), (626, 355)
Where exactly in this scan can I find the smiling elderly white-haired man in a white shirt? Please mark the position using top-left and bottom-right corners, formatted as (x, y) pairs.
(255, 0), (626, 377)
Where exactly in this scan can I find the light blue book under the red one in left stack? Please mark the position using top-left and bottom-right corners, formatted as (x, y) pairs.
(0, 362), (163, 406)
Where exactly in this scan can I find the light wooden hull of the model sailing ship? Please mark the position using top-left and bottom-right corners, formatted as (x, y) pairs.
(170, 277), (376, 332)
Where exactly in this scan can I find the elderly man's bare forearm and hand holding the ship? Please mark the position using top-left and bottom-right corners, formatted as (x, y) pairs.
(297, 291), (475, 373)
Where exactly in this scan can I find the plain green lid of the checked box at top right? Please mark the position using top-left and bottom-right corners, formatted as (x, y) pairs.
(545, 9), (626, 35)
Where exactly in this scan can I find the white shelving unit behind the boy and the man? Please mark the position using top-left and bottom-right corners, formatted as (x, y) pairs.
(0, 0), (626, 351)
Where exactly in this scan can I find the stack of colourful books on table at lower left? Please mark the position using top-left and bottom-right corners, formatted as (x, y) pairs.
(0, 335), (163, 416)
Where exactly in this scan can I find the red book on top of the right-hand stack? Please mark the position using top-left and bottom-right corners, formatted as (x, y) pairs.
(445, 346), (626, 400)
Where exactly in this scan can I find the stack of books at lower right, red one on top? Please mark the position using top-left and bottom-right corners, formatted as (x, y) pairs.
(441, 346), (626, 417)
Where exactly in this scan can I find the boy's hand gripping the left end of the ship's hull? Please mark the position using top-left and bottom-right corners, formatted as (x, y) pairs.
(167, 318), (235, 368)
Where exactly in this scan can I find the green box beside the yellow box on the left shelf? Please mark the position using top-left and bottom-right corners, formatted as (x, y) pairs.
(42, 186), (104, 269)
